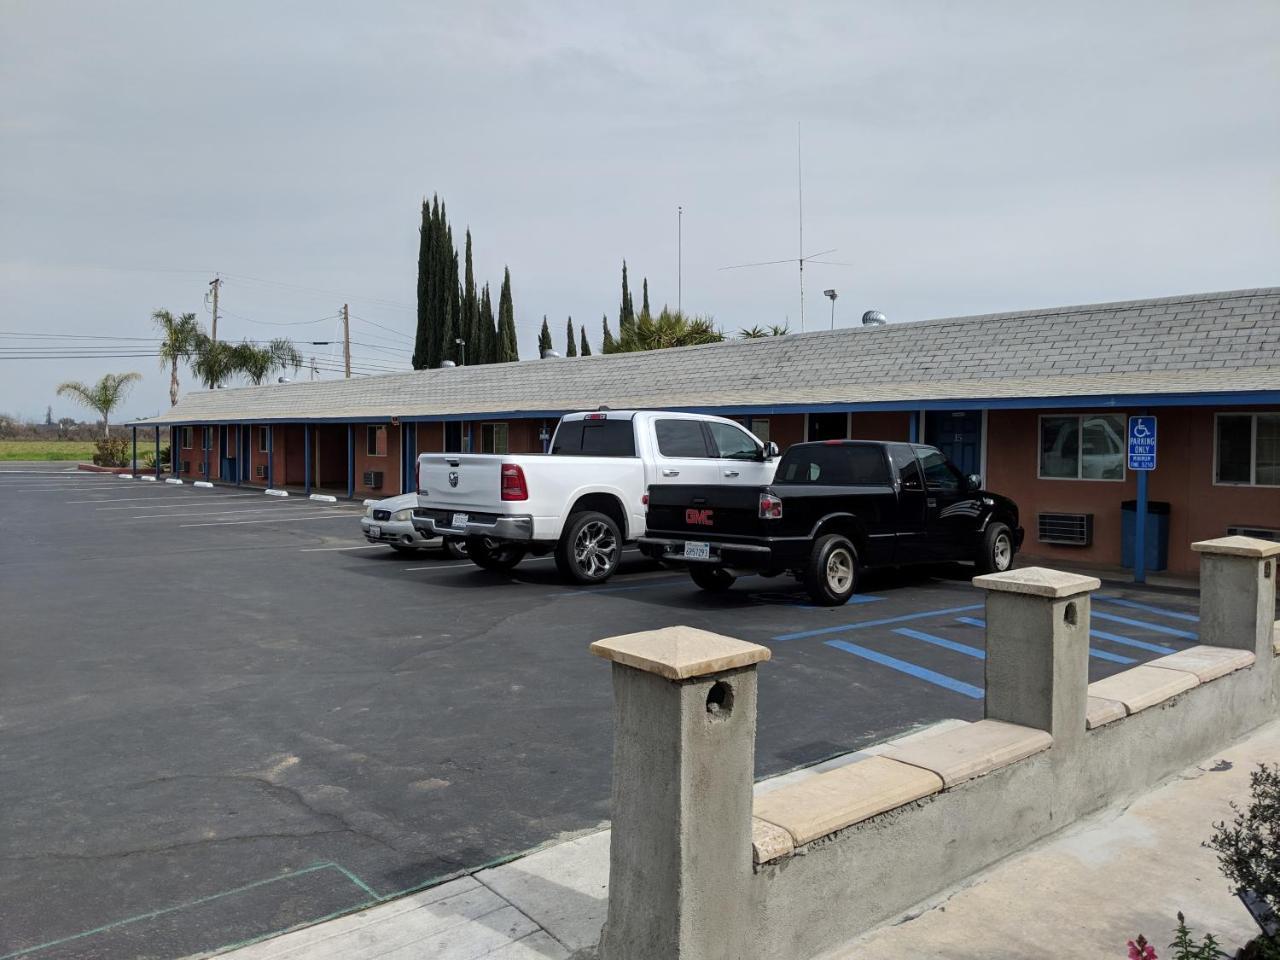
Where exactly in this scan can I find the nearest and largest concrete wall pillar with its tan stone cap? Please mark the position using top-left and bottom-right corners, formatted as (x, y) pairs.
(591, 627), (769, 960)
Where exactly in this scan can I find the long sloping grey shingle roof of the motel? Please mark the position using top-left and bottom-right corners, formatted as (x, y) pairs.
(129, 287), (1280, 424)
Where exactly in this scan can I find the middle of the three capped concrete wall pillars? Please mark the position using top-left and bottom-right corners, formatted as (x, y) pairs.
(973, 567), (1101, 758)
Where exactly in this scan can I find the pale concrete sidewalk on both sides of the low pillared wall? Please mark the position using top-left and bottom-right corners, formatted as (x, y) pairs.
(215, 722), (1280, 960)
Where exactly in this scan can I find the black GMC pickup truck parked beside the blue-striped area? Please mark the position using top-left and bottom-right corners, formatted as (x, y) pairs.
(640, 440), (1023, 607)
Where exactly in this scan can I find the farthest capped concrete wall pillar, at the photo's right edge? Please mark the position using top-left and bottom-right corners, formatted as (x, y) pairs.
(1192, 536), (1280, 663)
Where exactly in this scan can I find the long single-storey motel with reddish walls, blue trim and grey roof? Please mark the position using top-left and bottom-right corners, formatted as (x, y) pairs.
(132, 288), (1280, 575)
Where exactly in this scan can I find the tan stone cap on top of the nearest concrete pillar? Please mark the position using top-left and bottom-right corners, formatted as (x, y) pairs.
(591, 626), (771, 680)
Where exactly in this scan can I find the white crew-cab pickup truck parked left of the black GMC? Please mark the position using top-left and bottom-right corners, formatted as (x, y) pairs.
(413, 410), (778, 584)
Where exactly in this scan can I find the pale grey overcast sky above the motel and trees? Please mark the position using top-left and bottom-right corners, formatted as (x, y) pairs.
(0, 0), (1280, 419)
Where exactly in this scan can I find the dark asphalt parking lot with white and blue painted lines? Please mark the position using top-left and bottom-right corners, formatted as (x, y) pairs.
(0, 465), (1197, 960)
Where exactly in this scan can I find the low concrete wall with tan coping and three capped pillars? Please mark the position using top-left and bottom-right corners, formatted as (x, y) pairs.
(593, 538), (1280, 960)
